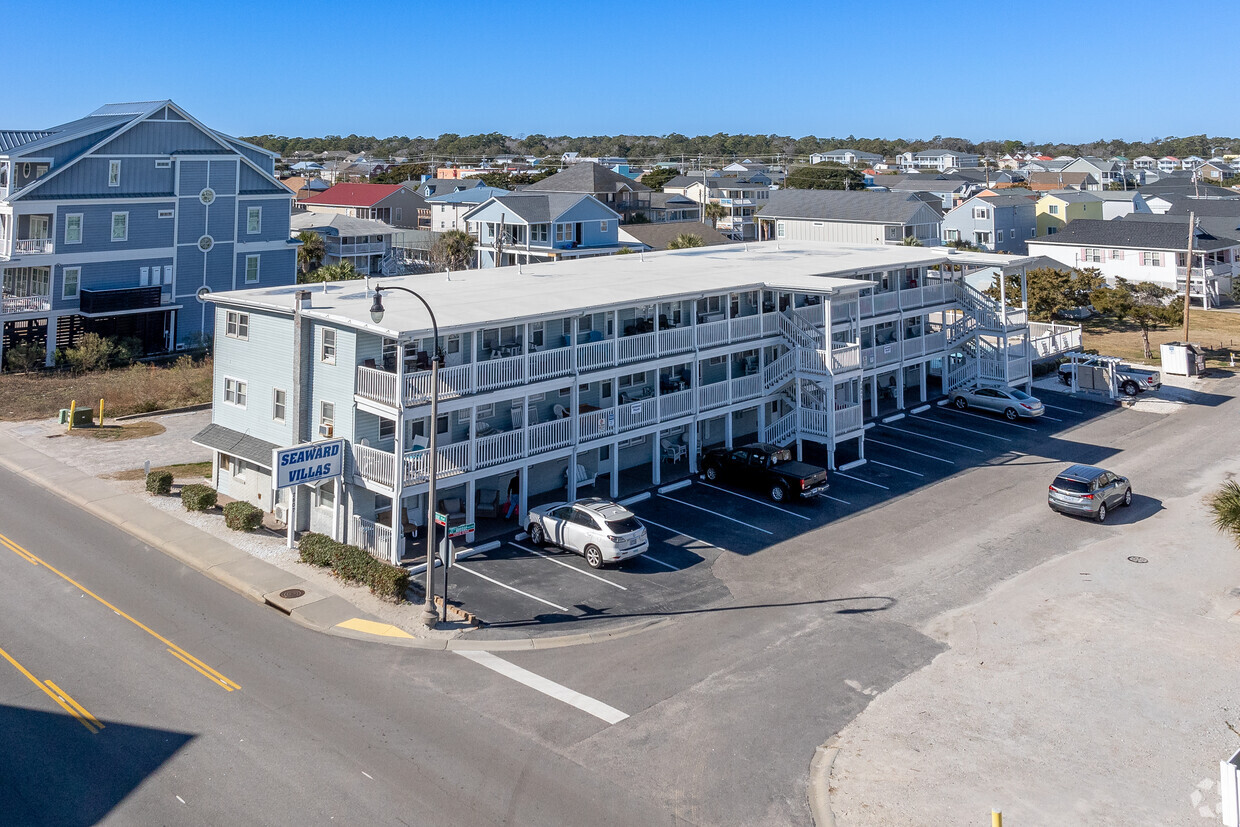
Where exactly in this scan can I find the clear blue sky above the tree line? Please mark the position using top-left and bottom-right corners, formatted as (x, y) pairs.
(0, 0), (1240, 143)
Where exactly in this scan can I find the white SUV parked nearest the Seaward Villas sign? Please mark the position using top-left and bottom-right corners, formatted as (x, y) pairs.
(526, 497), (650, 569)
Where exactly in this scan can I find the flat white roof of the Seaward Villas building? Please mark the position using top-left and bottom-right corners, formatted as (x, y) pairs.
(210, 242), (1023, 337)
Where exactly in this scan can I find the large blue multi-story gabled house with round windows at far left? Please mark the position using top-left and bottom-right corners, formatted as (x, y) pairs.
(0, 100), (296, 365)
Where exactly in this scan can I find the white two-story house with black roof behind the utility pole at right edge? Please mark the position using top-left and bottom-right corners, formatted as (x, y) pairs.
(1029, 216), (1240, 307)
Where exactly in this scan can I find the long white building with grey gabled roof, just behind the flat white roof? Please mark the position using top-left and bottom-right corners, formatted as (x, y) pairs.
(758, 190), (942, 247)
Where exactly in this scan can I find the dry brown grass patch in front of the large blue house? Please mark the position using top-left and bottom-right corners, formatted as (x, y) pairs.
(0, 356), (211, 420)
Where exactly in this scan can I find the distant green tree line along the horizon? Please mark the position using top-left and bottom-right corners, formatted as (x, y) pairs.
(236, 133), (1240, 164)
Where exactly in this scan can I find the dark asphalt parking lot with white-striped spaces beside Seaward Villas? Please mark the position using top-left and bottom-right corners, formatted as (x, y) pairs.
(449, 392), (1135, 635)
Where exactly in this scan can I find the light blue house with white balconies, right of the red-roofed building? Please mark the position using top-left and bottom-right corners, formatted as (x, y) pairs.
(463, 191), (620, 268)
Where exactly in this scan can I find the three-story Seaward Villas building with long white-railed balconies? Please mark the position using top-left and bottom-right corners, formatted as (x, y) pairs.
(196, 242), (1033, 559)
